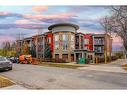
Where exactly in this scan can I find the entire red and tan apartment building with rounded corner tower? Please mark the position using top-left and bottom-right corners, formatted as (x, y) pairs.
(17, 23), (112, 63)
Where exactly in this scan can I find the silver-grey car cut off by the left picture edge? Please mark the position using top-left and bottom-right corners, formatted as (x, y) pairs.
(0, 56), (12, 70)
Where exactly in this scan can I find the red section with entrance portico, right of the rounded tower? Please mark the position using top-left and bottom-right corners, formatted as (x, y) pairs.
(74, 33), (95, 63)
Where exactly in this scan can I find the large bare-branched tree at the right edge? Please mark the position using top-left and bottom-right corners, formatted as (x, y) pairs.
(101, 6), (127, 57)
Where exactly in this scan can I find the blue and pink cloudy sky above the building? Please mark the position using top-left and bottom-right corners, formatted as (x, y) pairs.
(0, 6), (121, 50)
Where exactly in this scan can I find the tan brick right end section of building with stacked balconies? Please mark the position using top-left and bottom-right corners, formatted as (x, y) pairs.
(94, 34), (112, 58)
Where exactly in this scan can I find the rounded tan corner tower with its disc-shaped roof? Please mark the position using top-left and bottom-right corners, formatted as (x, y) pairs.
(48, 23), (78, 62)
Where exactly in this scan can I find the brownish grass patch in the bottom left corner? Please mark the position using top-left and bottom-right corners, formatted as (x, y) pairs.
(0, 76), (14, 88)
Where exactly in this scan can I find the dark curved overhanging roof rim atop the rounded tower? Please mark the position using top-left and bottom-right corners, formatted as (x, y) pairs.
(48, 23), (79, 30)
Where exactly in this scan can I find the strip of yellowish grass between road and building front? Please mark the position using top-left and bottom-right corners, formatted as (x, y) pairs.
(38, 62), (85, 69)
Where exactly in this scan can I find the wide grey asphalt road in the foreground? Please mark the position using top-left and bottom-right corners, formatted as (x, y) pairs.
(0, 64), (127, 89)
